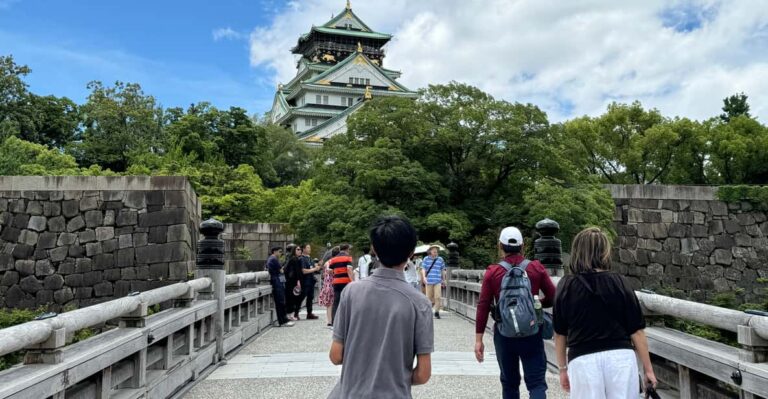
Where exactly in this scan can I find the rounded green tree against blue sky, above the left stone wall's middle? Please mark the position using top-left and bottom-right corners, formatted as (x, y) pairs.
(73, 82), (163, 172)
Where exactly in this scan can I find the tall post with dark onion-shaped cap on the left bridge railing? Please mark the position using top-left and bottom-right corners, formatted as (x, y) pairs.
(196, 219), (227, 362)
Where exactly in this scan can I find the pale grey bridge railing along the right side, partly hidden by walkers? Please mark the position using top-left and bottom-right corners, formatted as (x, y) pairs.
(445, 270), (768, 399)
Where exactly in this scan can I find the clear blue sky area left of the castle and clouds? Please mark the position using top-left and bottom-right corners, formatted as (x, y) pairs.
(0, 0), (287, 112)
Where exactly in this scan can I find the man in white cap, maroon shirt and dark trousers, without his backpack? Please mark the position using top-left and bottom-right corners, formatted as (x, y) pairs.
(475, 227), (555, 399)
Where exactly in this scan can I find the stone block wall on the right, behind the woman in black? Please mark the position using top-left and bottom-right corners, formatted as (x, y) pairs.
(607, 185), (768, 301)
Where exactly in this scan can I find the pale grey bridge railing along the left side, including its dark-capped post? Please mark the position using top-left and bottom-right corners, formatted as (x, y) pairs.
(0, 222), (274, 399)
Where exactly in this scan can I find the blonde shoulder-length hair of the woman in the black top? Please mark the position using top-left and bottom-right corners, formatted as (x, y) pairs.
(570, 227), (611, 273)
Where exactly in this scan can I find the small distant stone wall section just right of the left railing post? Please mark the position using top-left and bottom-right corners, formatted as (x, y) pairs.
(221, 223), (294, 273)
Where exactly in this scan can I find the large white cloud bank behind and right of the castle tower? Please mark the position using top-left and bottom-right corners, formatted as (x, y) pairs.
(250, 0), (768, 121)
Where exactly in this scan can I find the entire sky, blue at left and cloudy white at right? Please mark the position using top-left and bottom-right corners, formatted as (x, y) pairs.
(0, 0), (768, 122)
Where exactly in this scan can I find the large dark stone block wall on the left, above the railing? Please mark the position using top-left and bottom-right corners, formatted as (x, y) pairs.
(0, 176), (200, 309)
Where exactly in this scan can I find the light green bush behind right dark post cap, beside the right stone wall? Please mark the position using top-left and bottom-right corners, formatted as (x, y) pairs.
(525, 182), (615, 251)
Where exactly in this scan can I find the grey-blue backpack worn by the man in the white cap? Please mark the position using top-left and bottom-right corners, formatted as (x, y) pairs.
(496, 259), (539, 338)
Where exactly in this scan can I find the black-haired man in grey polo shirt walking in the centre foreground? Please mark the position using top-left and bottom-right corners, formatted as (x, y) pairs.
(329, 216), (434, 399)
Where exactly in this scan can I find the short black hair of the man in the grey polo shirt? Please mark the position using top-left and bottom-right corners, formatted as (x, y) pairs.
(369, 216), (416, 267)
